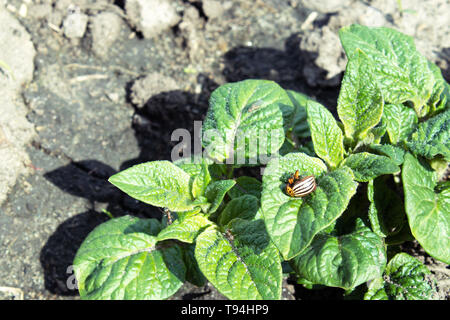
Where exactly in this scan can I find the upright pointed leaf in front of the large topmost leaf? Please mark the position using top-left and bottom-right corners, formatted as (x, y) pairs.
(337, 50), (384, 140)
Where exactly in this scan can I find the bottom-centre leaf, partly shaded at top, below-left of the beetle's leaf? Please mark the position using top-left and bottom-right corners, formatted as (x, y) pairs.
(195, 219), (282, 300)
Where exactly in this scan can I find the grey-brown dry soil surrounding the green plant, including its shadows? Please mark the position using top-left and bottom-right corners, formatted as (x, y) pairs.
(0, 0), (450, 300)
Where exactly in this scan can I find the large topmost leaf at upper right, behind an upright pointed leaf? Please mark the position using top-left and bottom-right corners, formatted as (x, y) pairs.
(339, 24), (435, 117)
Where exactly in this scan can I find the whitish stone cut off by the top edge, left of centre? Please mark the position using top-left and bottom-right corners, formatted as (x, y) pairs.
(125, 0), (181, 38)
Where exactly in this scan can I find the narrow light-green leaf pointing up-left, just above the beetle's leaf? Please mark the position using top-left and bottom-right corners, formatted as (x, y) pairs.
(306, 100), (344, 168)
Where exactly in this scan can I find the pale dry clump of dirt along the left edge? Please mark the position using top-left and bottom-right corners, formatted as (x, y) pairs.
(0, 7), (36, 203)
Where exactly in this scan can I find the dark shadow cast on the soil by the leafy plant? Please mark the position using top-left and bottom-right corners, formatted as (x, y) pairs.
(40, 35), (338, 299)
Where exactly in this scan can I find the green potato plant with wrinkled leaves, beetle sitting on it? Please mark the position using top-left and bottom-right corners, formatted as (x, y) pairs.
(74, 25), (450, 299)
